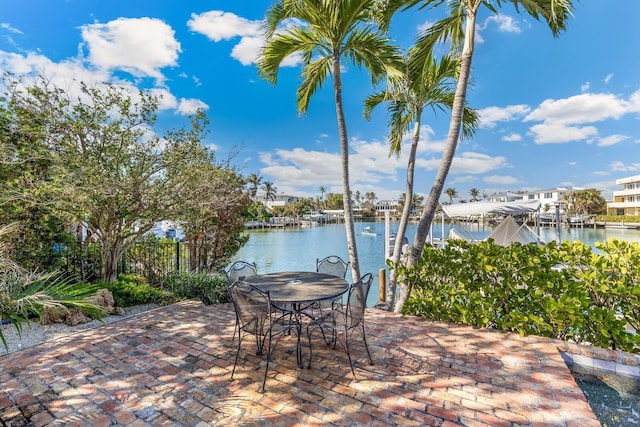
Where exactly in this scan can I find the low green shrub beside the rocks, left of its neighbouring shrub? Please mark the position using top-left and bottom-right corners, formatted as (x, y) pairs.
(104, 274), (175, 307)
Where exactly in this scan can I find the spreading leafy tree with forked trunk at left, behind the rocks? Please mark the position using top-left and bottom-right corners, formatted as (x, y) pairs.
(4, 78), (212, 281)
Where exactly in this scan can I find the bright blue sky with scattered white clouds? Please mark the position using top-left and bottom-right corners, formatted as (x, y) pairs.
(0, 0), (640, 200)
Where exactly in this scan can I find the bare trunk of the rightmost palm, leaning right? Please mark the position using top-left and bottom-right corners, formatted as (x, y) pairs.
(393, 7), (481, 313)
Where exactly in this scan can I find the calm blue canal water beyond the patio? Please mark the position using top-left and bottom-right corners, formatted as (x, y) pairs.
(235, 222), (640, 307)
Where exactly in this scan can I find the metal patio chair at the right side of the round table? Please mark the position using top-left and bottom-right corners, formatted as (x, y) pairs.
(307, 273), (373, 379)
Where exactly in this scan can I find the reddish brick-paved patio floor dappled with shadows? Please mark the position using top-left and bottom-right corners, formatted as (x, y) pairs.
(0, 301), (600, 427)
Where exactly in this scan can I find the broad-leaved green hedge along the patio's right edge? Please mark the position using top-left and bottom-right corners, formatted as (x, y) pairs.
(397, 240), (640, 352)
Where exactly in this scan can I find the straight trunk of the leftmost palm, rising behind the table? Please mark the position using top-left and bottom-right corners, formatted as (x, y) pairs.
(333, 56), (360, 283)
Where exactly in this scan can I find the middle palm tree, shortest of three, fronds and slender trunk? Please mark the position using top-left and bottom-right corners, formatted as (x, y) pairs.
(364, 49), (478, 308)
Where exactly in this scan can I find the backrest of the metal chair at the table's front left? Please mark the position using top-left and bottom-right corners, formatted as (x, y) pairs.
(229, 280), (271, 336)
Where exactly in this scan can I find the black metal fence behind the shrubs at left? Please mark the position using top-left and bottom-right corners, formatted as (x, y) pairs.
(66, 241), (218, 284)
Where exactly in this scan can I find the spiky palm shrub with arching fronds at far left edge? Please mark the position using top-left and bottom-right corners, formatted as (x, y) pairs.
(0, 225), (104, 349)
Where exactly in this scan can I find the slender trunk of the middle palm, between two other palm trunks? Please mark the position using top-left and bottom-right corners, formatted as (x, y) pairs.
(386, 110), (422, 309)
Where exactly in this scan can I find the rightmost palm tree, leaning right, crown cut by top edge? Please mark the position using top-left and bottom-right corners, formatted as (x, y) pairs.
(384, 0), (573, 311)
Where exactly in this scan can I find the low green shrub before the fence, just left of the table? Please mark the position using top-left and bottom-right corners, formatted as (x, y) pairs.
(163, 273), (231, 305)
